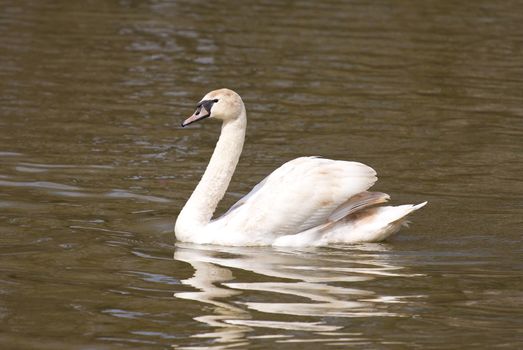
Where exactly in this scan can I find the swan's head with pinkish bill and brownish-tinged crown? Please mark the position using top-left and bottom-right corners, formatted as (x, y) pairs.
(182, 89), (245, 127)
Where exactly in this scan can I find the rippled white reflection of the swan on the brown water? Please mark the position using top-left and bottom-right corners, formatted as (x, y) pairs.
(174, 243), (420, 347)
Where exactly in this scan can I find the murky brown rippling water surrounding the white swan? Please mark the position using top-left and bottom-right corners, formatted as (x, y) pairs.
(0, 0), (523, 349)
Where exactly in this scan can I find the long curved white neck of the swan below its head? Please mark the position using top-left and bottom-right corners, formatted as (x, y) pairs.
(175, 107), (247, 238)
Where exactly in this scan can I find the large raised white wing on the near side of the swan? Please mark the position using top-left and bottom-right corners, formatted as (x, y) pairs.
(219, 157), (377, 238)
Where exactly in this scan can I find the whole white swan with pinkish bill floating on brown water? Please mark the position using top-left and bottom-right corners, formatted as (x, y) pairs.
(174, 89), (427, 247)
